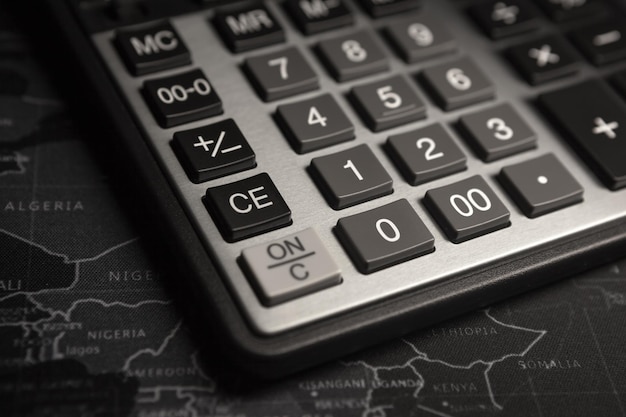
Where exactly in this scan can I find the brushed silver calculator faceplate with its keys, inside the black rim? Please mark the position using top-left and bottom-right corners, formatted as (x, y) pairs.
(94, 0), (626, 335)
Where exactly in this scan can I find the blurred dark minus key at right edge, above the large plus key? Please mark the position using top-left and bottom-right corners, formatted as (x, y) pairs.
(571, 21), (626, 66)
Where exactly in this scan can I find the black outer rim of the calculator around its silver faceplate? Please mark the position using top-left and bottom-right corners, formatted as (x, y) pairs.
(44, 0), (626, 379)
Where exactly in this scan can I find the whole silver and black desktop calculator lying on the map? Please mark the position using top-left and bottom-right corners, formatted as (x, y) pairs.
(46, 0), (626, 377)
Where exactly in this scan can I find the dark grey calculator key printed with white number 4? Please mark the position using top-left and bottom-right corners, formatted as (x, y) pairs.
(276, 94), (354, 153)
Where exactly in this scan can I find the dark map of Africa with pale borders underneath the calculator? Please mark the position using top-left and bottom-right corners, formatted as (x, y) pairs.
(0, 8), (626, 417)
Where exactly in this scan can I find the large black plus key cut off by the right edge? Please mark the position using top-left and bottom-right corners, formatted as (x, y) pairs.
(539, 80), (626, 190)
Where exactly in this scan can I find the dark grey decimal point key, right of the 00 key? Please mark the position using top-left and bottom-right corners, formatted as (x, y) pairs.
(500, 154), (583, 218)
